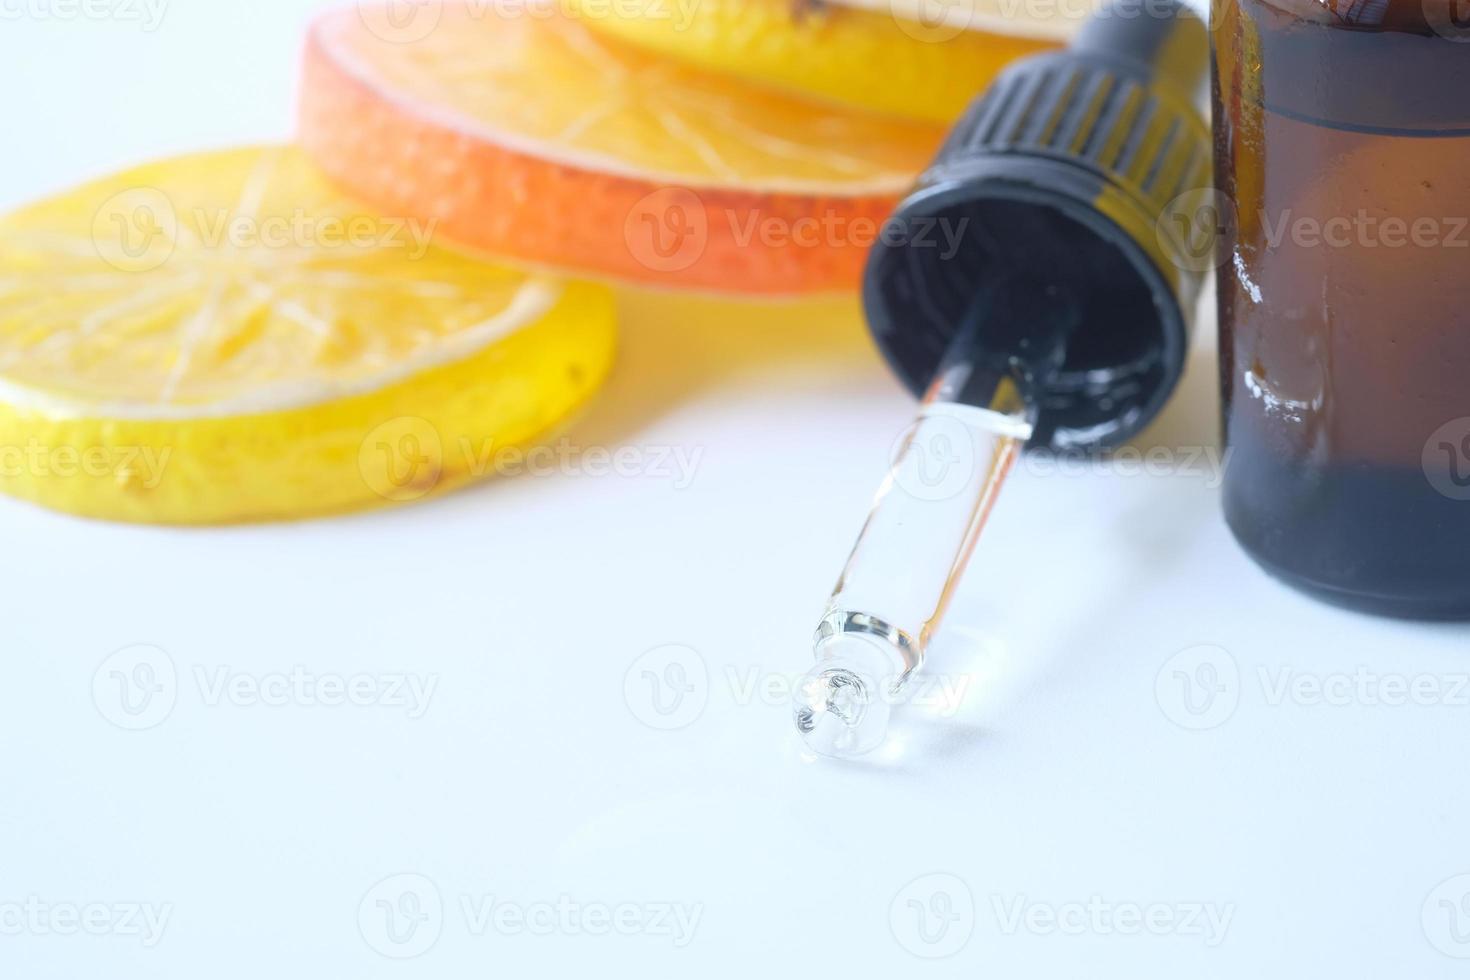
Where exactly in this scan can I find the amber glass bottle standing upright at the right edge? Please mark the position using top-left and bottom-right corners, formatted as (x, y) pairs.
(1213, 0), (1470, 619)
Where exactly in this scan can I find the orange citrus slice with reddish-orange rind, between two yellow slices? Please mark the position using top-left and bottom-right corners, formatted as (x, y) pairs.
(300, 0), (942, 295)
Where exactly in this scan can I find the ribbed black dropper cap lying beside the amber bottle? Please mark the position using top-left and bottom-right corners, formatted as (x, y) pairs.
(863, 0), (1211, 450)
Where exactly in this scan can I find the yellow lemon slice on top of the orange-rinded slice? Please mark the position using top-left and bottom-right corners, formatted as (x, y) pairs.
(566, 0), (1069, 122)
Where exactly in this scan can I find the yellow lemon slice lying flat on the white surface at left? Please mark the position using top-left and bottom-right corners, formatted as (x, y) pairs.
(0, 147), (614, 523)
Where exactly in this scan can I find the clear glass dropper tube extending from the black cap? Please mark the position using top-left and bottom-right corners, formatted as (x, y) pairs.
(792, 276), (1078, 757)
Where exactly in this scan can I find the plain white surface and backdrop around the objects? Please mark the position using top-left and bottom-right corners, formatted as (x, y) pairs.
(0, 0), (1470, 979)
